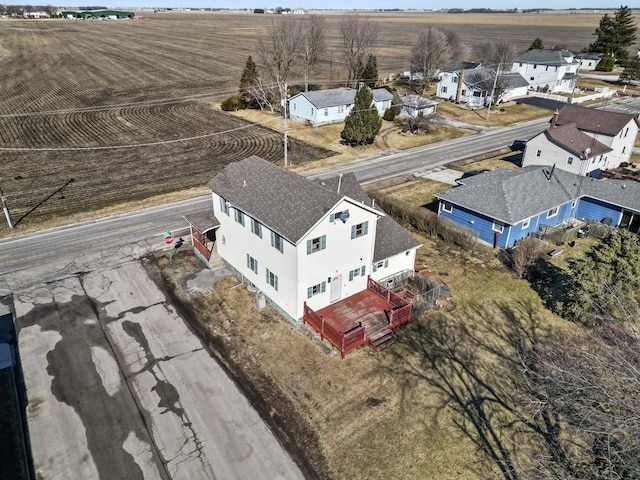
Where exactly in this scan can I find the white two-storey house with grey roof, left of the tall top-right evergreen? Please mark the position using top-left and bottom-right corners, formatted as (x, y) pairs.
(511, 49), (580, 93)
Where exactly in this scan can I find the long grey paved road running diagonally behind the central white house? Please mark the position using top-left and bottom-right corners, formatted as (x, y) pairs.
(0, 98), (640, 284)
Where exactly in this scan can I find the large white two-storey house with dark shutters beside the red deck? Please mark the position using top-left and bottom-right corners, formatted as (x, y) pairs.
(198, 155), (420, 321)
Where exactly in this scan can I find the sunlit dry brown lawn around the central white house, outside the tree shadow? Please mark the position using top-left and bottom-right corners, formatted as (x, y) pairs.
(160, 227), (572, 480)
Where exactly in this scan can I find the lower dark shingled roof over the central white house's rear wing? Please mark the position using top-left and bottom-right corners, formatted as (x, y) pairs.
(320, 173), (421, 262)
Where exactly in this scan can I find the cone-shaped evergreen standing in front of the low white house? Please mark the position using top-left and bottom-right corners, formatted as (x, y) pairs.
(340, 86), (382, 147)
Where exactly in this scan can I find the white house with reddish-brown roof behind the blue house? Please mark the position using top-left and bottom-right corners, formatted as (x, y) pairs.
(522, 105), (638, 177)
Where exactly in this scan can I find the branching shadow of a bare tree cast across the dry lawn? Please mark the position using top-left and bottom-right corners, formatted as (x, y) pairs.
(393, 303), (566, 480)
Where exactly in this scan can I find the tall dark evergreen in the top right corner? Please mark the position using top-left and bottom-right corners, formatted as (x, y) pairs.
(589, 6), (636, 60)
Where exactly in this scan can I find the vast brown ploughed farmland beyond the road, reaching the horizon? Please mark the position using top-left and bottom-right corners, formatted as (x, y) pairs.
(0, 11), (636, 229)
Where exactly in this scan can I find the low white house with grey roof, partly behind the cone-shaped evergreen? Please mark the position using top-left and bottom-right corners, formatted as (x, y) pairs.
(289, 87), (393, 127)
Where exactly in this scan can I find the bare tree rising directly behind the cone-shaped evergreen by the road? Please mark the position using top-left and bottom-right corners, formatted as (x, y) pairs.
(340, 14), (378, 88)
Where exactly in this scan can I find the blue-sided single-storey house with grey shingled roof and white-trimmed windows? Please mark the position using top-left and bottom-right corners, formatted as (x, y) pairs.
(436, 165), (640, 248)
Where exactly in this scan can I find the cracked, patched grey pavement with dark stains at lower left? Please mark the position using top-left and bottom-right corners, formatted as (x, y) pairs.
(14, 260), (303, 480)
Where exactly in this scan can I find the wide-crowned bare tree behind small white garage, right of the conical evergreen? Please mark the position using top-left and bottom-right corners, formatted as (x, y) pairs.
(411, 27), (461, 95)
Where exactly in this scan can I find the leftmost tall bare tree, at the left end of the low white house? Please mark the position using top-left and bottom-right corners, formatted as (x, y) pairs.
(258, 15), (302, 112)
